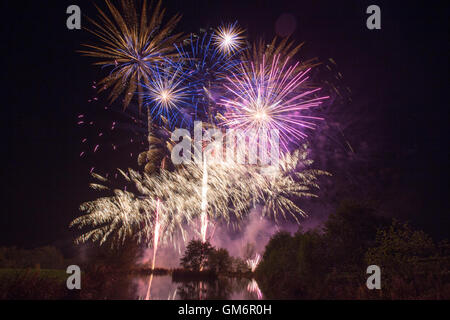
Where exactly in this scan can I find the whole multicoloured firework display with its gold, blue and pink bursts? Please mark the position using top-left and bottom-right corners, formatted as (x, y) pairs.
(70, 0), (328, 298)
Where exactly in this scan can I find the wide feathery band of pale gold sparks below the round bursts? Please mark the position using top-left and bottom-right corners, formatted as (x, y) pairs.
(71, 146), (330, 246)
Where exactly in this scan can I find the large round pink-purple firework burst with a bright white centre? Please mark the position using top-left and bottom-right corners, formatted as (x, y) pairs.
(218, 55), (328, 148)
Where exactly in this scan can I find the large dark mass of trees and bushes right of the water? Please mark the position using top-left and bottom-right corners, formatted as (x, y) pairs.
(256, 202), (450, 299)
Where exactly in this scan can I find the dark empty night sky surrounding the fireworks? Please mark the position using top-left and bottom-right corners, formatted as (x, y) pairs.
(0, 0), (450, 247)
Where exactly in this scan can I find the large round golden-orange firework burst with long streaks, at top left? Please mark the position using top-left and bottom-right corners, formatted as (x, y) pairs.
(80, 0), (182, 109)
